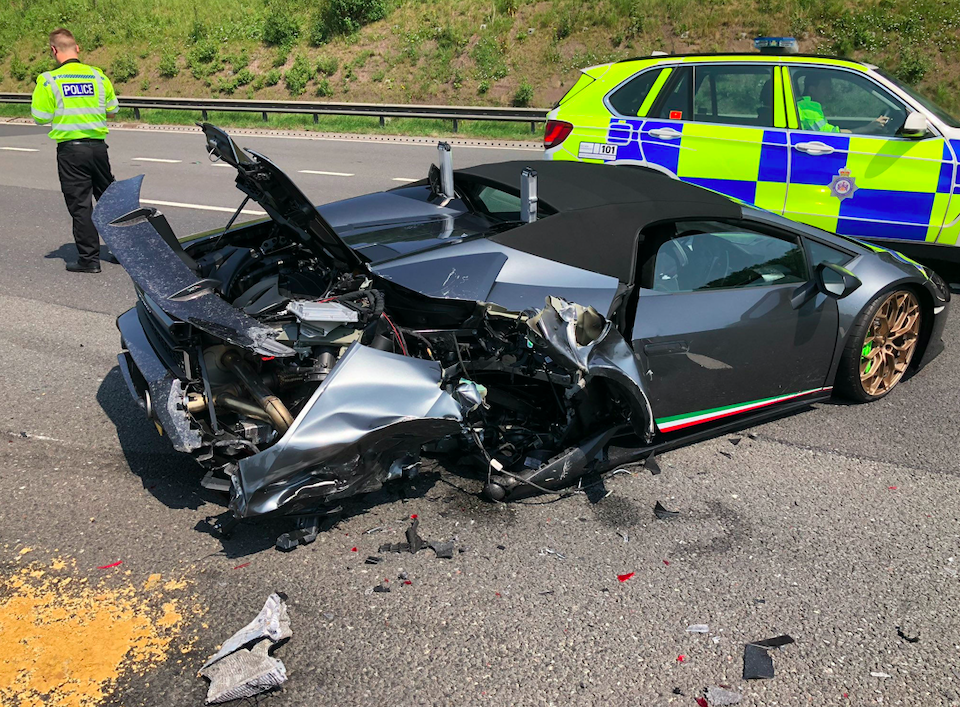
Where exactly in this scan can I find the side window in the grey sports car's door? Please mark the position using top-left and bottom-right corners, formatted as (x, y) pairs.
(651, 222), (807, 292)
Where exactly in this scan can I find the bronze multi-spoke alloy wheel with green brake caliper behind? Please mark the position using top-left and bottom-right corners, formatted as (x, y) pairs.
(860, 290), (920, 397)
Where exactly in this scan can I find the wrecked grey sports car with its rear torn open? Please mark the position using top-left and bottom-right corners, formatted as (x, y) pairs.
(95, 124), (950, 518)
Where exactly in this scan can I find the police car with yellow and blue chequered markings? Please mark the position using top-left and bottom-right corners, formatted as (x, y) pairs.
(544, 38), (960, 274)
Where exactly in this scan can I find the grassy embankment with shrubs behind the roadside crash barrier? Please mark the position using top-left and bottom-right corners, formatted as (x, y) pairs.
(0, 0), (960, 139)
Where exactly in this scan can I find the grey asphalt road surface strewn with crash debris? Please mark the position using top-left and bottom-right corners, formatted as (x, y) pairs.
(0, 125), (960, 707)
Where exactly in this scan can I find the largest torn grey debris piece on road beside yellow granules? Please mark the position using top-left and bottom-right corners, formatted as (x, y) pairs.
(200, 593), (293, 704)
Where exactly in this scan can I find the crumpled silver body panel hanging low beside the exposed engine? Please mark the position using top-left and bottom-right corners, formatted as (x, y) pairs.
(231, 343), (462, 517)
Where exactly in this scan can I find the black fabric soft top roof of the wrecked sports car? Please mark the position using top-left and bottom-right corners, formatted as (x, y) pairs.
(456, 160), (742, 283)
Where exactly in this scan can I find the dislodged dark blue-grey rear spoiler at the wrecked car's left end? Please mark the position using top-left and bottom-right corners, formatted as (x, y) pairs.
(93, 175), (293, 356)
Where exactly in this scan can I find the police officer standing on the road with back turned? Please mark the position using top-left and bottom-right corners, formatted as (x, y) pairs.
(30, 28), (119, 273)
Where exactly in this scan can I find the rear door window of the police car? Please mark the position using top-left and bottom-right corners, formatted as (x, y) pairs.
(693, 65), (773, 127)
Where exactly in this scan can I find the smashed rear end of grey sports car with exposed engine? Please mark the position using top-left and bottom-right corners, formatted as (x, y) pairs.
(96, 126), (654, 518)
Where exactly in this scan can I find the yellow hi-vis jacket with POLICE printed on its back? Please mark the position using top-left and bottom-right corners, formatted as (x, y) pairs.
(30, 59), (119, 142)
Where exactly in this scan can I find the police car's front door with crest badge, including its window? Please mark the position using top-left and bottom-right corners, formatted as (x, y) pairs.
(784, 66), (953, 241)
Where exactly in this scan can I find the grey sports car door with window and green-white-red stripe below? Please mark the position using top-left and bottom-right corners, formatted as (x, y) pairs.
(632, 221), (838, 432)
